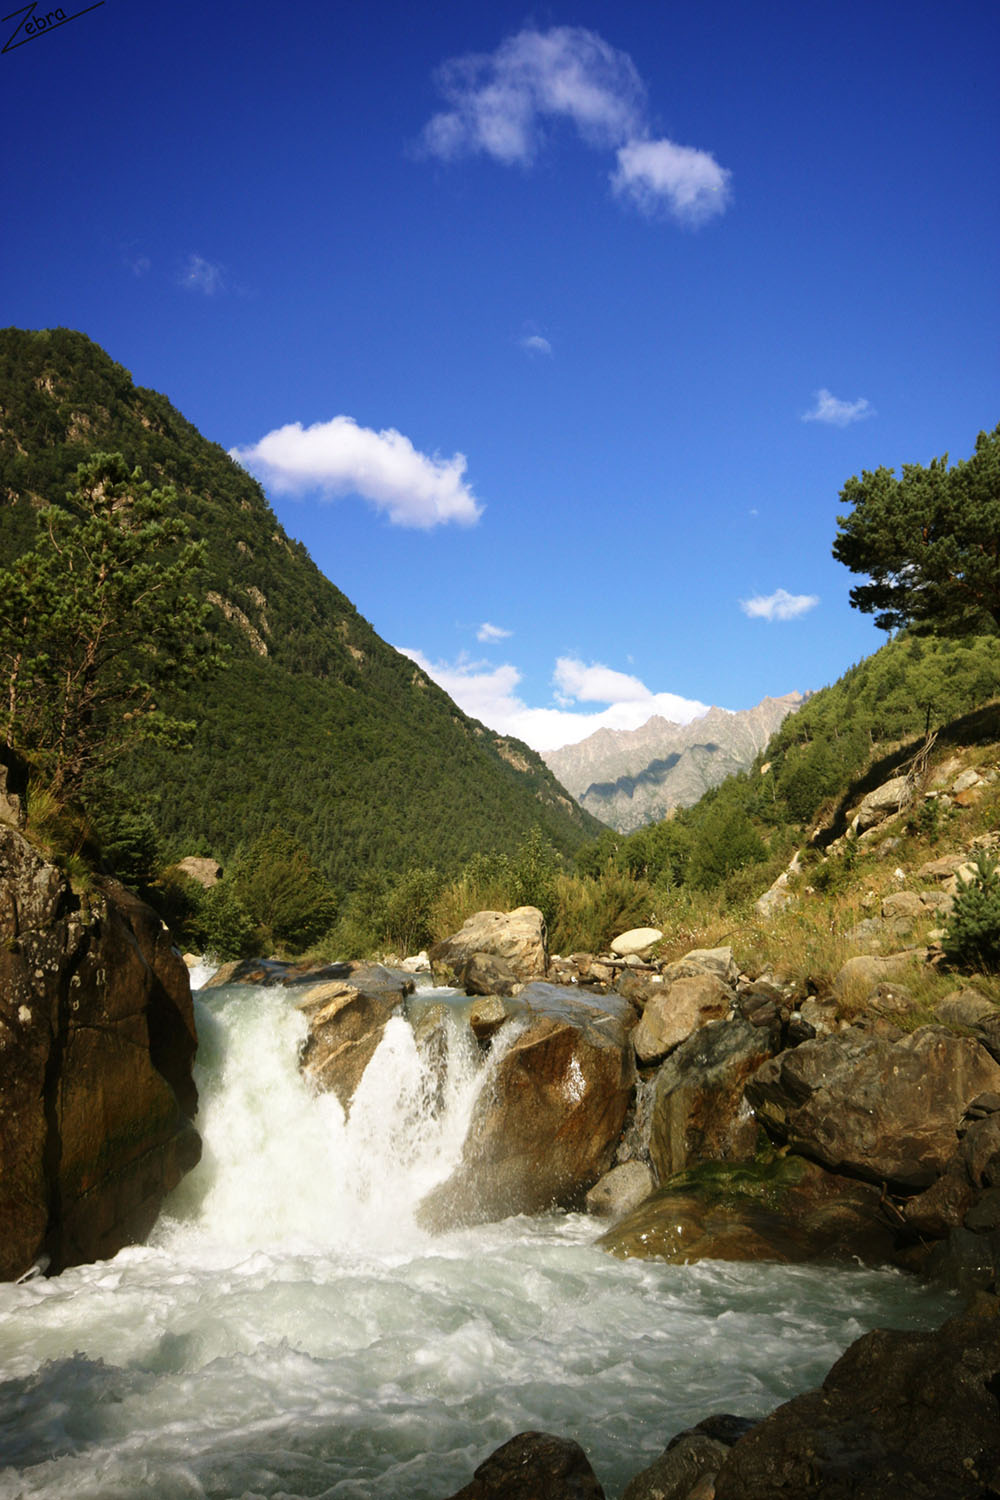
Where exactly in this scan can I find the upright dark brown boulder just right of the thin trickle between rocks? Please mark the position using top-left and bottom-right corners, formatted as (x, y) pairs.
(650, 1014), (780, 1182)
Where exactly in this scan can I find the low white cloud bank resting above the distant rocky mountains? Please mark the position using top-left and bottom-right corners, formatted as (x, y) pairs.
(399, 647), (708, 752)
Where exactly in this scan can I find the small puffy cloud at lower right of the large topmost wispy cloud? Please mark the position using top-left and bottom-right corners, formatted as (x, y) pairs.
(612, 140), (732, 227)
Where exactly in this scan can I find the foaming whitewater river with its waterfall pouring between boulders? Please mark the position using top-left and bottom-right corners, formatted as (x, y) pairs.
(0, 986), (948, 1500)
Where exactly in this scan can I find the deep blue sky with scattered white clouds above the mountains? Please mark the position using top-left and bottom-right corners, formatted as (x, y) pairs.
(0, 0), (1000, 749)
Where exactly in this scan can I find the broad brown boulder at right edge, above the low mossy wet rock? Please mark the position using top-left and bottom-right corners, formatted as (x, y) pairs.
(747, 1026), (1000, 1193)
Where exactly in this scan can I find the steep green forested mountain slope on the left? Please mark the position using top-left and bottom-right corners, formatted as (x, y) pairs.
(0, 329), (600, 885)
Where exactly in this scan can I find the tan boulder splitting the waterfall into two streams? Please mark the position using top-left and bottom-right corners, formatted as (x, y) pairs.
(297, 965), (414, 1110)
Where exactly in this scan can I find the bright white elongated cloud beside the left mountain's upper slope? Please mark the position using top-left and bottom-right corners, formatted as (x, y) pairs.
(229, 416), (483, 528)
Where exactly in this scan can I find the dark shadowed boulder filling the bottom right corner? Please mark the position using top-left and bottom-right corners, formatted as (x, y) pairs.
(714, 1296), (1000, 1500)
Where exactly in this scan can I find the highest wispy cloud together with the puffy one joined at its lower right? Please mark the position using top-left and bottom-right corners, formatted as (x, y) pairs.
(420, 26), (730, 227)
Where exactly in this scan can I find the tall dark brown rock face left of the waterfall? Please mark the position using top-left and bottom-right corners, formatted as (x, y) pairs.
(0, 827), (201, 1280)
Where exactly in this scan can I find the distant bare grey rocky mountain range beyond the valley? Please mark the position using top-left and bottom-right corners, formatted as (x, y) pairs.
(543, 693), (805, 834)
